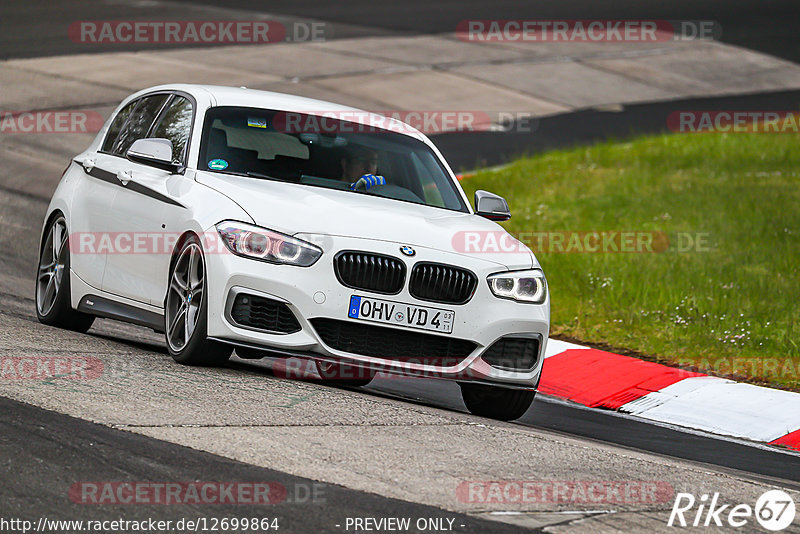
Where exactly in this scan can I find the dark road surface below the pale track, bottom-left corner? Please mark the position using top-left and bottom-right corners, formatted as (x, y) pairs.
(0, 397), (525, 534)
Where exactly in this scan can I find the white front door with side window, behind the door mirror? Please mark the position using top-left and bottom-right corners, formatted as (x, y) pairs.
(103, 95), (195, 306)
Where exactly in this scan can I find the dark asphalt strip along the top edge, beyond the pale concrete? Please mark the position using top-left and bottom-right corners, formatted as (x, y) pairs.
(0, 0), (800, 61)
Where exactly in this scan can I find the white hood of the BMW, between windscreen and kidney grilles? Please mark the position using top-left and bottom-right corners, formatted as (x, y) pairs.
(196, 172), (538, 269)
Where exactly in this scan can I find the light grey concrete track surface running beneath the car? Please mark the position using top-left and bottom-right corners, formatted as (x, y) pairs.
(0, 184), (800, 531)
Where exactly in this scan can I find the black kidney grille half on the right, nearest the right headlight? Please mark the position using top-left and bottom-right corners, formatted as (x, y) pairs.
(408, 263), (478, 304)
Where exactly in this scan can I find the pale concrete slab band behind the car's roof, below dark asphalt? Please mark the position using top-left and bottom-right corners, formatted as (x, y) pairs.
(0, 34), (800, 134)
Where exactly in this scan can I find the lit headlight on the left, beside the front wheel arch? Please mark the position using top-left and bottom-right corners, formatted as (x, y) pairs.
(217, 221), (322, 267)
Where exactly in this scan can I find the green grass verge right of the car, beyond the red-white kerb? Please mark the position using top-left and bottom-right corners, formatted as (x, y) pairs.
(462, 133), (800, 390)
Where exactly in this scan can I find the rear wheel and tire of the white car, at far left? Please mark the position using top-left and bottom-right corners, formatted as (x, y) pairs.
(35, 213), (94, 333)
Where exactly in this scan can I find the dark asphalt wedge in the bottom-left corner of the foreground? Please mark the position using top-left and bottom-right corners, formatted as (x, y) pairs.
(0, 399), (517, 532)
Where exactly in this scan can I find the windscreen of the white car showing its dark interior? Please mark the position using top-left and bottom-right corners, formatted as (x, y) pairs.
(199, 108), (463, 211)
